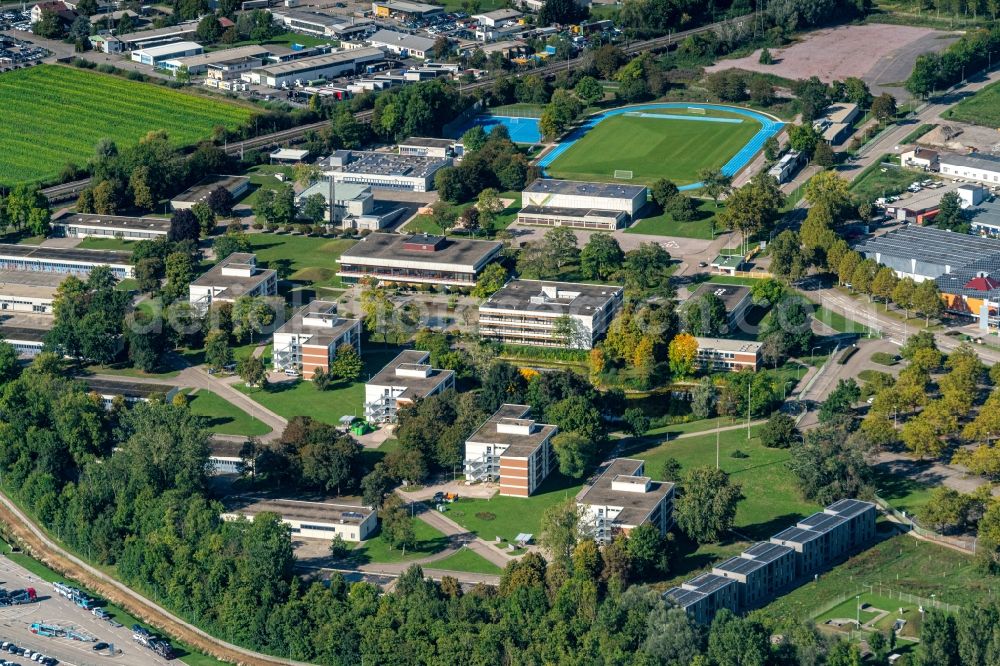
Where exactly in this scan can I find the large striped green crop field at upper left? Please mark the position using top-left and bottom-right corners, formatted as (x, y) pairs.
(0, 65), (253, 186)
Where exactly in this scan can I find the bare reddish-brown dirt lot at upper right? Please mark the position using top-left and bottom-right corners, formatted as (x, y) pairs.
(707, 24), (958, 98)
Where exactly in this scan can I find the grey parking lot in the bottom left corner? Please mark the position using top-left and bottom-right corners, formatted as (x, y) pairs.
(0, 557), (169, 666)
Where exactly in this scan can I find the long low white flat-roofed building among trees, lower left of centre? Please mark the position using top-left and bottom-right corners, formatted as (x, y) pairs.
(222, 497), (378, 541)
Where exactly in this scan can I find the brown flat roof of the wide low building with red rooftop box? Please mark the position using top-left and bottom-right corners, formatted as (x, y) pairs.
(337, 233), (503, 269)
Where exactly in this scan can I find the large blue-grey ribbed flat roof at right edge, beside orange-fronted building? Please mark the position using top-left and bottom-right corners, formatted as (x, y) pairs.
(854, 224), (1000, 270)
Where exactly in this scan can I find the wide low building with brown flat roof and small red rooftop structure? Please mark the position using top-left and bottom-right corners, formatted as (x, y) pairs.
(337, 233), (503, 288)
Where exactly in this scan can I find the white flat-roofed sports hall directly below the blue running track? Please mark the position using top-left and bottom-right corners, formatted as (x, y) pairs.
(517, 178), (649, 230)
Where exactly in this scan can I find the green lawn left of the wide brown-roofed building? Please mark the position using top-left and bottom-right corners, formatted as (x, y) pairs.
(250, 234), (357, 287)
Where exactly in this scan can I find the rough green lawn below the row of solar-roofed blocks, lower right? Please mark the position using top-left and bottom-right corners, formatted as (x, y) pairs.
(758, 535), (994, 622)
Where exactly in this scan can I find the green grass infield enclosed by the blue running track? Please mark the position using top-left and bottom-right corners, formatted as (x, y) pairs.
(545, 109), (760, 185)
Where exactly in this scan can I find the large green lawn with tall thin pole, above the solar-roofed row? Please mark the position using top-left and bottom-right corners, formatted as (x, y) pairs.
(625, 426), (821, 540)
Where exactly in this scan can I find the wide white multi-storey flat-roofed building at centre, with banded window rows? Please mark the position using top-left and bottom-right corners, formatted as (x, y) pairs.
(479, 280), (624, 349)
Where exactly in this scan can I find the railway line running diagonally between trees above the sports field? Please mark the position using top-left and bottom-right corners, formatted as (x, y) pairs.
(42, 15), (752, 203)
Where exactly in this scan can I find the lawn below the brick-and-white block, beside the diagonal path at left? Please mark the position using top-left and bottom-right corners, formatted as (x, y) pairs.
(234, 345), (400, 425)
